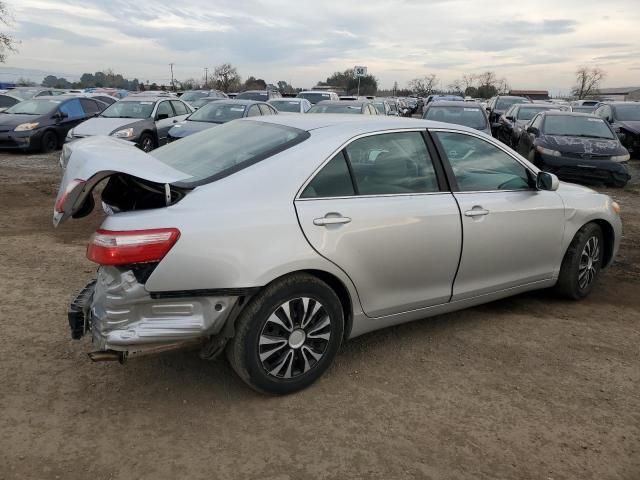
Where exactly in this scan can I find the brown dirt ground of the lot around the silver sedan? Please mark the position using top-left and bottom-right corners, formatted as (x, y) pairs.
(0, 153), (640, 480)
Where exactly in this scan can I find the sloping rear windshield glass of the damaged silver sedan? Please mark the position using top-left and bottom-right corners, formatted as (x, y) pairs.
(150, 119), (309, 187)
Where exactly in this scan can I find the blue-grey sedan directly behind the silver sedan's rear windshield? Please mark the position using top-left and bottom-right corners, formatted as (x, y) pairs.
(168, 99), (278, 142)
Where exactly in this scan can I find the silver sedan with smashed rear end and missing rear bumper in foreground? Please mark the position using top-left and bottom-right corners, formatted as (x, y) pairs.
(54, 115), (622, 394)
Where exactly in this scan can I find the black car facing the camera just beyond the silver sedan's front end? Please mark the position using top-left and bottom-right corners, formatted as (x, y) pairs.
(518, 110), (631, 187)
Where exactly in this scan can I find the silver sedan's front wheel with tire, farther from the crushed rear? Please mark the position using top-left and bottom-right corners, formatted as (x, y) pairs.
(555, 223), (604, 300)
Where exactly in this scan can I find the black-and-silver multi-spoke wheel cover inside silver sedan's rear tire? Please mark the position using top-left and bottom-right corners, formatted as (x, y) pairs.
(258, 297), (332, 379)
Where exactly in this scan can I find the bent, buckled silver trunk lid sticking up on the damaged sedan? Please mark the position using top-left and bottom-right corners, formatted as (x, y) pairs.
(53, 136), (190, 227)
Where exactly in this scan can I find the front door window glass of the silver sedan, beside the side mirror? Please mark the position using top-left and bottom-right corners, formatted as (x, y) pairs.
(434, 132), (530, 192)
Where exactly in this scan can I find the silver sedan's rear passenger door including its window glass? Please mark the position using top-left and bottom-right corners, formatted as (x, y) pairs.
(295, 131), (462, 317)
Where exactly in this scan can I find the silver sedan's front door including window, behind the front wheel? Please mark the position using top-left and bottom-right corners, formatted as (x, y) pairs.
(432, 130), (565, 301)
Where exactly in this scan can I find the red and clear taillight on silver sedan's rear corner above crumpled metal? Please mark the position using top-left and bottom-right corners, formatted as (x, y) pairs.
(87, 228), (180, 265)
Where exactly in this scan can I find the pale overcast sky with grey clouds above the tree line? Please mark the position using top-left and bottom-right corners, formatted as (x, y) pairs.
(6, 0), (640, 92)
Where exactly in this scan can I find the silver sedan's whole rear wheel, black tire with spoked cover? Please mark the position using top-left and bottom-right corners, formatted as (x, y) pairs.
(227, 273), (344, 395)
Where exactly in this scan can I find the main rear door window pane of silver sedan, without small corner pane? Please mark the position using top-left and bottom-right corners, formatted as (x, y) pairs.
(346, 132), (438, 195)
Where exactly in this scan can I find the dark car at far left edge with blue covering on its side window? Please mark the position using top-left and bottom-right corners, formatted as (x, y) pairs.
(0, 96), (105, 152)
